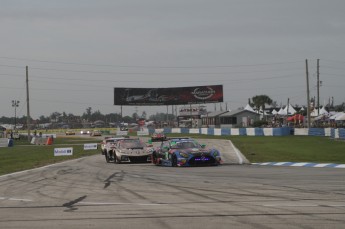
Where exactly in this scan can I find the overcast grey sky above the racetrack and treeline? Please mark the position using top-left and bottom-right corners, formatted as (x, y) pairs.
(0, 0), (345, 118)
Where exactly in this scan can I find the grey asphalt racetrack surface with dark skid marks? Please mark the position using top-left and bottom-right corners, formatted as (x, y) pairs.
(0, 140), (345, 229)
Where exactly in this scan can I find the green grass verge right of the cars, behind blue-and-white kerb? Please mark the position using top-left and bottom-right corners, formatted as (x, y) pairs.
(164, 134), (345, 164)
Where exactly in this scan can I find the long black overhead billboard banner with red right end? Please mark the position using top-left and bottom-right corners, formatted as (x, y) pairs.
(114, 85), (223, 106)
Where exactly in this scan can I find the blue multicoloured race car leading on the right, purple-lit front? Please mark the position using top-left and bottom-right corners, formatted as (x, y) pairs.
(152, 138), (222, 167)
